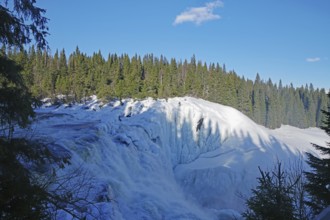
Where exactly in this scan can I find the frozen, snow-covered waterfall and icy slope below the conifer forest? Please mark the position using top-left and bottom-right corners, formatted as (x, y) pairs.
(32, 97), (330, 219)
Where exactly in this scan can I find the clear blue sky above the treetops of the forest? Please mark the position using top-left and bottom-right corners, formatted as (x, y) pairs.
(38, 0), (330, 89)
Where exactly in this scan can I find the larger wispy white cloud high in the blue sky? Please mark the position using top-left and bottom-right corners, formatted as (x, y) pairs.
(173, 0), (223, 25)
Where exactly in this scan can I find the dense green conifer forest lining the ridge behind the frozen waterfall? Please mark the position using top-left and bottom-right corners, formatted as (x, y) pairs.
(2, 47), (328, 128)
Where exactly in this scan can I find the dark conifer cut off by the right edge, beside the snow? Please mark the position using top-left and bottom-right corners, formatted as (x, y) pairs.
(305, 92), (330, 217)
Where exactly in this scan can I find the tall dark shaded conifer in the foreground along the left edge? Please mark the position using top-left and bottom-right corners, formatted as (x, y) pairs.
(0, 0), (98, 220)
